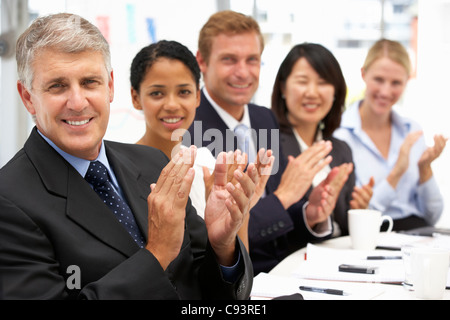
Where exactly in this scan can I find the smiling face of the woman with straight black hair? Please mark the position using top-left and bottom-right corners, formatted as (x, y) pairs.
(282, 58), (335, 128)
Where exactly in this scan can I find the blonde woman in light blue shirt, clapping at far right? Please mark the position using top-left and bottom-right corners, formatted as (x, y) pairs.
(335, 39), (447, 230)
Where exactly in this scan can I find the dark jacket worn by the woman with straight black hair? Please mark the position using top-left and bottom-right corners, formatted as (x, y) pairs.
(280, 130), (355, 235)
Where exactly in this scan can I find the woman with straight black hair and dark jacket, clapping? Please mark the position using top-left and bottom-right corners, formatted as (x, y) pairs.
(272, 43), (373, 236)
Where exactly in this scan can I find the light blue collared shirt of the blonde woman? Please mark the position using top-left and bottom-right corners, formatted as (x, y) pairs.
(334, 102), (444, 225)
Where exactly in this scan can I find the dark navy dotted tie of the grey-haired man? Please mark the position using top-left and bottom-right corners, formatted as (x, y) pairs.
(85, 161), (145, 248)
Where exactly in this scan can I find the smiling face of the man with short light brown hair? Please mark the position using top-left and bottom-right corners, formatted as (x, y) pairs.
(197, 32), (262, 119)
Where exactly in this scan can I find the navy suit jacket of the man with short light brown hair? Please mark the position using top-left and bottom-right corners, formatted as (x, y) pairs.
(183, 92), (332, 274)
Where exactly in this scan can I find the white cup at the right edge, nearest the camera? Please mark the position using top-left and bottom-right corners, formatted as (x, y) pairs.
(411, 247), (450, 300)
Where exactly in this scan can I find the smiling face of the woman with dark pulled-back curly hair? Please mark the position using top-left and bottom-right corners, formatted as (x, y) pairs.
(131, 58), (200, 154)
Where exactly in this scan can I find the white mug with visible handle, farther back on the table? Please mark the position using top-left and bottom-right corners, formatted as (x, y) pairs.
(348, 209), (394, 250)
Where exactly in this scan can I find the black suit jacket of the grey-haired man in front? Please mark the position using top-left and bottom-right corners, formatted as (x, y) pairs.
(0, 129), (253, 299)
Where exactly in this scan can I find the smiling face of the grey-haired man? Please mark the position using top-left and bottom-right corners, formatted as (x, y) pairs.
(18, 49), (114, 160)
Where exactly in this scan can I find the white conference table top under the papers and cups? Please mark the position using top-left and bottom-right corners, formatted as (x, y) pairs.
(252, 232), (450, 300)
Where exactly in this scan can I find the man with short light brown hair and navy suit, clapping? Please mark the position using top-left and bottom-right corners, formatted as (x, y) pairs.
(183, 11), (348, 274)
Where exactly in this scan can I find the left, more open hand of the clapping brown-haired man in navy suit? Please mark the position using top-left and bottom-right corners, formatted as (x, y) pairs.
(274, 141), (332, 209)
